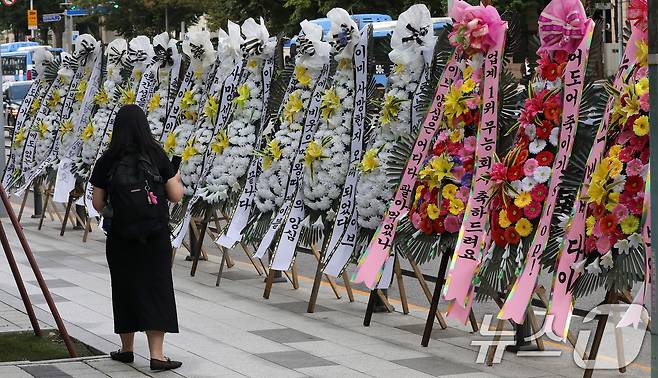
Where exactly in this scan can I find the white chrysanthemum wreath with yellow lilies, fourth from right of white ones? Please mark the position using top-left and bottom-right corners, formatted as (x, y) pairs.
(200, 18), (276, 204)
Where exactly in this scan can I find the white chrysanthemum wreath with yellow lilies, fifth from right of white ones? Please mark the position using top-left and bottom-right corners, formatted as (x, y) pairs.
(180, 21), (242, 196)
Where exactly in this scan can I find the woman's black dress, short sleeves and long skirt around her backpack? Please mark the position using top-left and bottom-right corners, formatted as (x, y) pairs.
(90, 153), (178, 333)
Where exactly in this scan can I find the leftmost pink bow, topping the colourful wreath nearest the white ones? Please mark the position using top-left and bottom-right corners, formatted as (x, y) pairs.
(449, 0), (505, 52)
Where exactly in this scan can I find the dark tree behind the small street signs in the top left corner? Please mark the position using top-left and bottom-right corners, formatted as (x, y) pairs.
(0, 0), (64, 47)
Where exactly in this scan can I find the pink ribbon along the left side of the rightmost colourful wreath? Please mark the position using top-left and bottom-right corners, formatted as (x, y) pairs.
(545, 29), (642, 339)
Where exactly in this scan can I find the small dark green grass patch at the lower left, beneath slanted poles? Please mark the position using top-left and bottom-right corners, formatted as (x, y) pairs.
(0, 330), (103, 362)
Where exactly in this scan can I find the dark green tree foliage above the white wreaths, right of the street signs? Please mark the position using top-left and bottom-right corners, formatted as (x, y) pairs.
(75, 0), (204, 38)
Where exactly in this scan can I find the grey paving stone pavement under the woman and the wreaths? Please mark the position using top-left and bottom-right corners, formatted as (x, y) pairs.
(0, 214), (650, 378)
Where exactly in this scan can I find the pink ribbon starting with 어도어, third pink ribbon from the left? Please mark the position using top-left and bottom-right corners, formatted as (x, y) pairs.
(498, 20), (594, 324)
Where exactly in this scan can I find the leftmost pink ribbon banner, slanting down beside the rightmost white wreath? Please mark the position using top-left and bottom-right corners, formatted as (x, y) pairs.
(354, 54), (459, 289)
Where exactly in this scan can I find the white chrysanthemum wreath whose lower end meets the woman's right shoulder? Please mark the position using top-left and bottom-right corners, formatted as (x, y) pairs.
(164, 30), (215, 156)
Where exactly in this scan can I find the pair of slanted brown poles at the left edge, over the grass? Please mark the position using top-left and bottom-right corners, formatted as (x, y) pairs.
(0, 185), (77, 358)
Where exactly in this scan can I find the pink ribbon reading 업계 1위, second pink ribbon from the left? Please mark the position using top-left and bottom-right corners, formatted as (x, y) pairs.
(444, 34), (505, 315)
